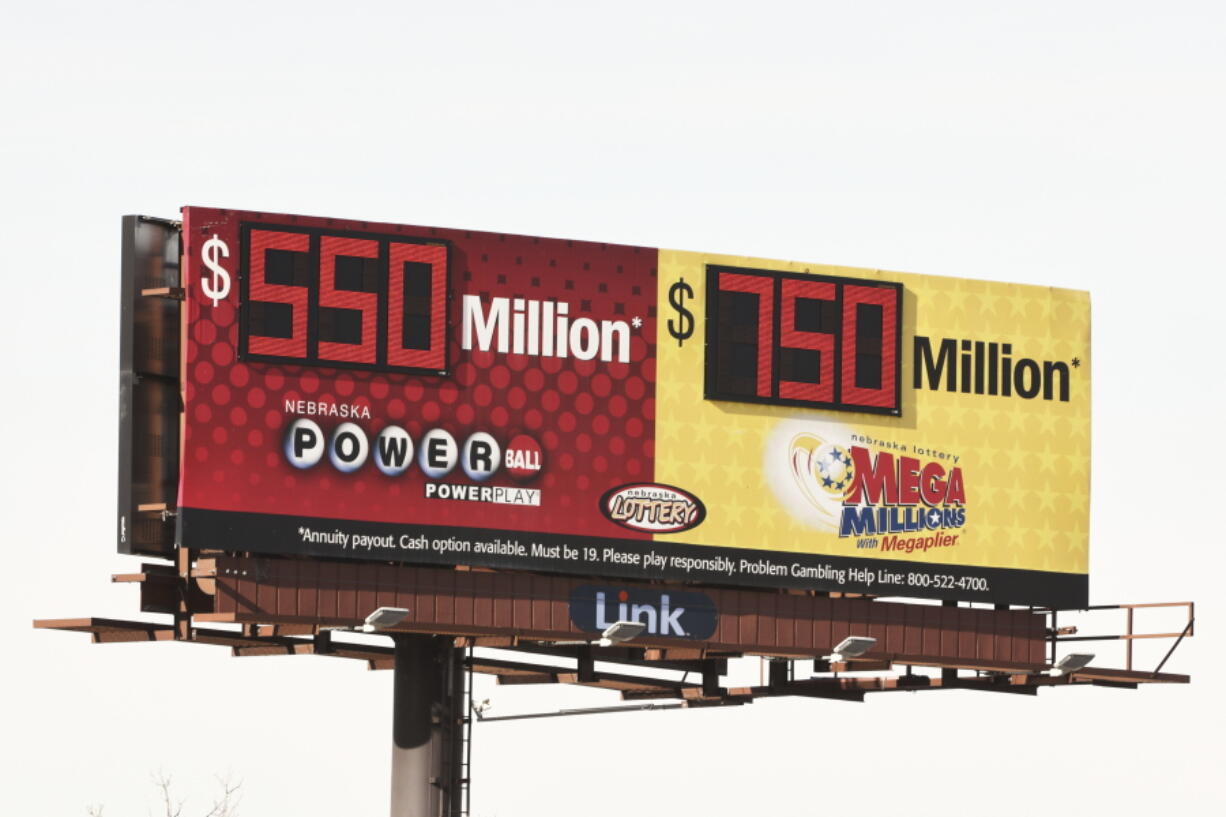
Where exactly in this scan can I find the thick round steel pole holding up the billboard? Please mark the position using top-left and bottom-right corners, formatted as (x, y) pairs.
(391, 634), (443, 817)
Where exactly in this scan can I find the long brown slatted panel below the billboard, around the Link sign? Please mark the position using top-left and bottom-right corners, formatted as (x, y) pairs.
(208, 557), (1046, 670)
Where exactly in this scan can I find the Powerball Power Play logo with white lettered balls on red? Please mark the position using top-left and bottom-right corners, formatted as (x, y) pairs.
(282, 417), (543, 505)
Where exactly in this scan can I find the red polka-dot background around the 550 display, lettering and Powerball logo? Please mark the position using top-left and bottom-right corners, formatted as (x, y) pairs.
(183, 210), (656, 537)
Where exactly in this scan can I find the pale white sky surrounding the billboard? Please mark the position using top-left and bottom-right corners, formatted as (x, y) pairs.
(0, 0), (1226, 817)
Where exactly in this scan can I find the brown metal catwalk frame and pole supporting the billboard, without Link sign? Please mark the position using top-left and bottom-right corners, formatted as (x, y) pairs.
(34, 548), (1194, 817)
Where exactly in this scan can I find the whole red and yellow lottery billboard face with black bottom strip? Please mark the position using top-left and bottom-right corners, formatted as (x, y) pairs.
(129, 207), (1090, 606)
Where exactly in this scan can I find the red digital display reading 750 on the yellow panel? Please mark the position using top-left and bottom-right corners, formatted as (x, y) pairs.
(705, 266), (902, 416)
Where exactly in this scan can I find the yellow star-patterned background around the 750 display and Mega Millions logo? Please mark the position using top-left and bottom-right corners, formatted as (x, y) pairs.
(656, 250), (1091, 573)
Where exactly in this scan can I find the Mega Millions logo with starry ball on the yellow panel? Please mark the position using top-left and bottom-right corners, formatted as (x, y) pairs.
(767, 428), (966, 553)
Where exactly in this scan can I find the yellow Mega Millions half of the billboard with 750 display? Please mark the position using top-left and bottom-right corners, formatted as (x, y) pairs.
(655, 250), (1090, 604)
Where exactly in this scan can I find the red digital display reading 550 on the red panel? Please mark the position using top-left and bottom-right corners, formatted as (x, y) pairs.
(239, 223), (449, 374)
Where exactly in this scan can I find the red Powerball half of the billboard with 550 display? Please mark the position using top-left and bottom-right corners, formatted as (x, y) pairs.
(179, 207), (656, 549)
